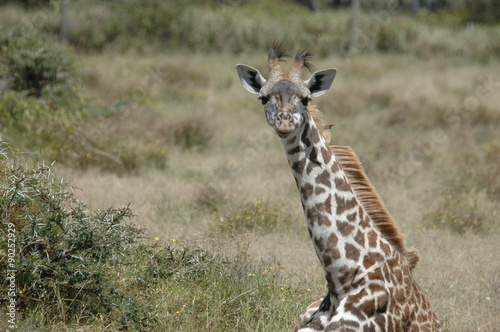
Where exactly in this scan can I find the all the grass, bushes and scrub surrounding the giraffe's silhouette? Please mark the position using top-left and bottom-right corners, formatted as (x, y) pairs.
(0, 0), (500, 331)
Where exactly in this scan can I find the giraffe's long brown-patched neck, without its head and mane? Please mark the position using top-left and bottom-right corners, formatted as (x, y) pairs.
(282, 117), (391, 305)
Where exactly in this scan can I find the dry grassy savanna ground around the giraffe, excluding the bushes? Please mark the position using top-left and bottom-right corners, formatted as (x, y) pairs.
(0, 3), (500, 331)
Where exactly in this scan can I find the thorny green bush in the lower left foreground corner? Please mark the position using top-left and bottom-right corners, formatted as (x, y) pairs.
(0, 155), (153, 328)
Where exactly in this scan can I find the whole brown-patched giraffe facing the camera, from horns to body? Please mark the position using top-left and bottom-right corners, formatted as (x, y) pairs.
(236, 44), (441, 332)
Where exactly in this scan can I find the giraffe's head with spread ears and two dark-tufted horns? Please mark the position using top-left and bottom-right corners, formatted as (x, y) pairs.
(236, 44), (337, 138)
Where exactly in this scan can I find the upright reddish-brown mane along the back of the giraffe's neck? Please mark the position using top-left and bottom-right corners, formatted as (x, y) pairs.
(330, 145), (420, 269)
